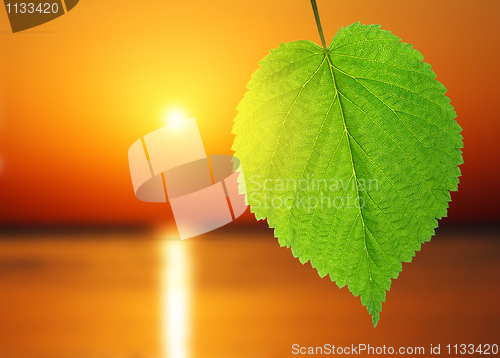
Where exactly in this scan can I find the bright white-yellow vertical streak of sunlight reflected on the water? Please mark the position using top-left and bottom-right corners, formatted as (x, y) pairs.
(161, 240), (190, 358)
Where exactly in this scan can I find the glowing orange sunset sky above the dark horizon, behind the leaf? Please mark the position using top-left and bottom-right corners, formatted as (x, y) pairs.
(0, 0), (500, 223)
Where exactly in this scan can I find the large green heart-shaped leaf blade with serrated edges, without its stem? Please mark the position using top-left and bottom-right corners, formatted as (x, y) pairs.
(233, 23), (463, 325)
